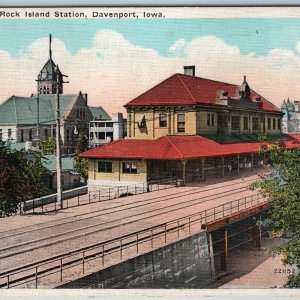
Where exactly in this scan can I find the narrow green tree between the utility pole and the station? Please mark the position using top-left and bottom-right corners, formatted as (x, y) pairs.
(74, 131), (88, 182)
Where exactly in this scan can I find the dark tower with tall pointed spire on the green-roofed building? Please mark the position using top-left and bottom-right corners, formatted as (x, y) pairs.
(37, 34), (63, 94)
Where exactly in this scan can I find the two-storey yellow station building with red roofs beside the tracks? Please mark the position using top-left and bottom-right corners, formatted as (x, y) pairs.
(80, 66), (300, 185)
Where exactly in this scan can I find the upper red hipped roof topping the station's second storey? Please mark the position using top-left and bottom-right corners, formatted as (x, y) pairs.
(125, 74), (279, 112)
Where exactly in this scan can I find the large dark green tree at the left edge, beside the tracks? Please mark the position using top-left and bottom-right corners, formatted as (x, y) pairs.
(0, 142), (48, 216)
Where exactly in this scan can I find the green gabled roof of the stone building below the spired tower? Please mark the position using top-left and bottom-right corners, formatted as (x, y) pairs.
(0, 94), (78, 125)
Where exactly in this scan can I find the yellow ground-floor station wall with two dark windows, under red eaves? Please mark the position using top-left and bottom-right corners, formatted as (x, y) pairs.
(88, 159), (147, 181)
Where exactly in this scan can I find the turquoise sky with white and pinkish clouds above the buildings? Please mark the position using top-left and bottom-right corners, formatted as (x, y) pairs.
(0, 12), (300, 113)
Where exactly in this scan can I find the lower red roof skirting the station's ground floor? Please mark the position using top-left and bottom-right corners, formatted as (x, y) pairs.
(79, 134), (300, 160)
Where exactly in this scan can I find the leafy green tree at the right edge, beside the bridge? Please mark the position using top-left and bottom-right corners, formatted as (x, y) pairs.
(254, 142), (300, 287)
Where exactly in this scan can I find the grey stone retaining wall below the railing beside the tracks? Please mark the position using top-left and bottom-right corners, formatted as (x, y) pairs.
(59, 232), (211, 289)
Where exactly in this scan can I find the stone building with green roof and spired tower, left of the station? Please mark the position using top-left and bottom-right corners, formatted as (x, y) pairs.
(0, 35), (108, 154)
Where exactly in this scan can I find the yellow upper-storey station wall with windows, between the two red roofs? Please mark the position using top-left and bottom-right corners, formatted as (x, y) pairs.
(128, 108), (280, 139)
